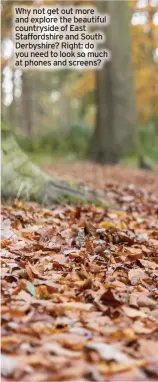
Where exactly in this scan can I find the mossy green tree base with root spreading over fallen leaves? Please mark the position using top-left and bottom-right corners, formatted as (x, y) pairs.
(1, 123), (117, 208)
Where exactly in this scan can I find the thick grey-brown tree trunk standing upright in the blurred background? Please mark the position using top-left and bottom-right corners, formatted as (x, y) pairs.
(91, 1), (137, 163)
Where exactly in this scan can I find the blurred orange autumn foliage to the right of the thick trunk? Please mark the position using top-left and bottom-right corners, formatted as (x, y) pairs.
(129, 0), (158, 123)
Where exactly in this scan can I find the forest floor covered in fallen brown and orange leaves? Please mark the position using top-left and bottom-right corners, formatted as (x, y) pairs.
(1, 163), (158, 382)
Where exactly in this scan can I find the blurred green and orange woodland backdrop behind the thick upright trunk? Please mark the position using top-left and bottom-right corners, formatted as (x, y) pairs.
(1, 0), (158, 166)
